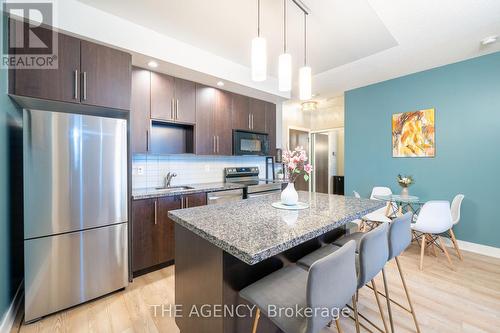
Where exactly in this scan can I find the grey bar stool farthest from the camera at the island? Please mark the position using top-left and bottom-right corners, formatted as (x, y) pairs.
(334, 212), (420, 333)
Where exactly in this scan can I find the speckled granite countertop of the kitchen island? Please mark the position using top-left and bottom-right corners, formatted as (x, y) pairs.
(169, 192), (385, 265)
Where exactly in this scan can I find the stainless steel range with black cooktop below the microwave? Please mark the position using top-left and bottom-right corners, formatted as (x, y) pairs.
(224, 167), (281, 199)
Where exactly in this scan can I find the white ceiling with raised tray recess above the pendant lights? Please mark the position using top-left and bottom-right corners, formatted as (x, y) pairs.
(80, 0), (500, 98)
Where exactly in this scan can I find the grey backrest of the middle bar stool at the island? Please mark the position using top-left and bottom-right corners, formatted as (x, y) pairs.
(358, 223), (389, 289)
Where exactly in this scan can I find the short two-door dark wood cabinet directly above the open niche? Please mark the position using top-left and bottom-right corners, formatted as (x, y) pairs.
(151, 72), (196, 124)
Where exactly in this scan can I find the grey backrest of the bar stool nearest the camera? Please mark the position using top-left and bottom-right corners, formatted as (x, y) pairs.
(304, 240), (356, 333)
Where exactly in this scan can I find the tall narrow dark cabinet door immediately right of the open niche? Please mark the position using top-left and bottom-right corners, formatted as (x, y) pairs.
(195, 84), (216, 155)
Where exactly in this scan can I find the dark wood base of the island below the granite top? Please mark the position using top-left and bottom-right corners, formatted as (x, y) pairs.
(175, 224), (345, 333)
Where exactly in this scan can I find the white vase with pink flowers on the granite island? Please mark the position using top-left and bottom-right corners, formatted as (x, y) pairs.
(281, 147), (312, 206)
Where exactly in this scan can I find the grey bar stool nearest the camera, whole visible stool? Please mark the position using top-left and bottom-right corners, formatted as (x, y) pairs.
(240, 242), (356, 333)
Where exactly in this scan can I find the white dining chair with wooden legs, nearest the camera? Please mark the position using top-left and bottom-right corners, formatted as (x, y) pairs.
(411, 201), (453, 270)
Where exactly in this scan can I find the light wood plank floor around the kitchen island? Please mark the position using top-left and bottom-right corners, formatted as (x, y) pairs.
(15, 246), (500, 333)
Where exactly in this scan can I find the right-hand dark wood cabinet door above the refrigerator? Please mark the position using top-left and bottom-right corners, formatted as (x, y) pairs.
(80, 40), (132, 110)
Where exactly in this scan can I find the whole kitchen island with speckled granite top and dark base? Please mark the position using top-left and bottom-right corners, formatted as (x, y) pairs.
(169, 192), (385, 333)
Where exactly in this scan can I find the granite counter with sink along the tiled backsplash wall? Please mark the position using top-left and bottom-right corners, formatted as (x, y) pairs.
(132, 182), (244, 200)
